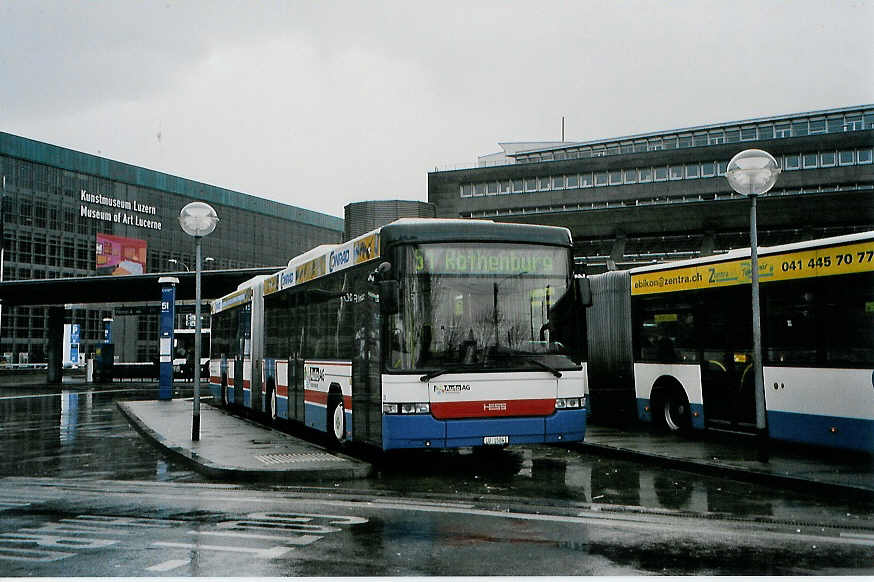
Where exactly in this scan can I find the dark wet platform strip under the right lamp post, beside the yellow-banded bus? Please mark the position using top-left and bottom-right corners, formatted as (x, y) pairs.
(582, 423), (874, 498)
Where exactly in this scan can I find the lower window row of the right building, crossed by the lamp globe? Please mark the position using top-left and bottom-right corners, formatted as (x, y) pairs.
(459, 148), (872, 198)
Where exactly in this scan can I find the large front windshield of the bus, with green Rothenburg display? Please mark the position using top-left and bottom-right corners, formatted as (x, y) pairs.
(386, 243), (576, 373)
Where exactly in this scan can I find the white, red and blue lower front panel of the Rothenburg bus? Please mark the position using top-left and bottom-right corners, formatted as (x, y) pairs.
(383, 367), (586, 450)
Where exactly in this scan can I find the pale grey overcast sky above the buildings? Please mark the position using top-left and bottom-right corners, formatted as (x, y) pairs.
(0, 0), (874, 217)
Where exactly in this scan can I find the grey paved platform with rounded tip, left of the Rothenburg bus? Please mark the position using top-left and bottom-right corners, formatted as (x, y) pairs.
(118, 398), (371, 483)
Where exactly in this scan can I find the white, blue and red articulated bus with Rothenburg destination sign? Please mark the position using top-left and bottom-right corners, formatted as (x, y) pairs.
(210, 219), (589, 450)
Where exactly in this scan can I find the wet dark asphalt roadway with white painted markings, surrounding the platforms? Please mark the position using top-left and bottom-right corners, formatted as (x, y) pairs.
(0, 385), (874, 577)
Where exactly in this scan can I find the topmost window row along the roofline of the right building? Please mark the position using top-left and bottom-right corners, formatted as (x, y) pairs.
(515, 111), (874, 164)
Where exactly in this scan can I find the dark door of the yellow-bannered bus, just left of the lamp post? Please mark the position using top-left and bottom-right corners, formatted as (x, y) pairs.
(697, 286), (756, 431)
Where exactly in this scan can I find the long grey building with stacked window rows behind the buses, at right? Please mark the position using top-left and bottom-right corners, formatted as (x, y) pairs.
(428, 105), (874, 272)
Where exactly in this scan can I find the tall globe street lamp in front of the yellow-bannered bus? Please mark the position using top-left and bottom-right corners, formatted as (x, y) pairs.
(725, 150), (780, 437)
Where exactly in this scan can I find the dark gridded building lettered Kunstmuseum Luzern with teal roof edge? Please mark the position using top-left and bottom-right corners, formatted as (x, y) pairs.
(0, 132), (343, 362)
